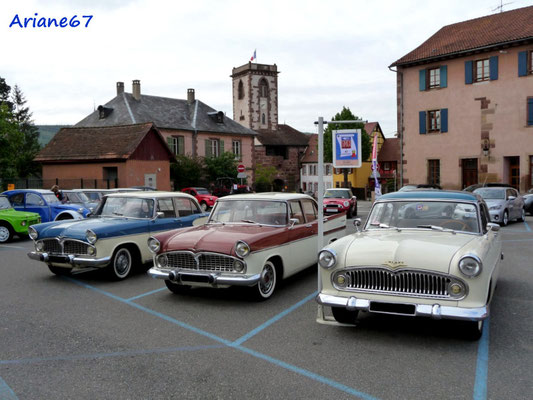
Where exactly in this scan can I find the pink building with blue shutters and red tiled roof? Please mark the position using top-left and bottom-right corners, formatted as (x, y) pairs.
(391, 7), (533, 191)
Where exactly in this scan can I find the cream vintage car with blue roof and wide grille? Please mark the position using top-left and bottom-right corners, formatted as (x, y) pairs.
(316, 190), (503, 339)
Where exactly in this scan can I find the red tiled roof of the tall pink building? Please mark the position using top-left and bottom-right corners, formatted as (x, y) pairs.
(391, 6), (533, 67)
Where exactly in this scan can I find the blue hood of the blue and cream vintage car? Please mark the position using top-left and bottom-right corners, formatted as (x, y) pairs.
(34, 217), (149, 240)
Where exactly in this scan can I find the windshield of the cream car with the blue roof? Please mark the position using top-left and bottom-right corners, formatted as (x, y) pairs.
(365, 201), (479, 233)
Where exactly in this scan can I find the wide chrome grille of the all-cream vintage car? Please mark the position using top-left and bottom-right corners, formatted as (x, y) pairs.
(333, 268), (454, 298)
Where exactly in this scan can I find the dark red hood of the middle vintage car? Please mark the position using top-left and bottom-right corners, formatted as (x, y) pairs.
(156, 224), (287, 254)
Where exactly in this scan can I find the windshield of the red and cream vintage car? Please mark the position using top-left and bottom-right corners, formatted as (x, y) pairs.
(209, 200), (288, 225)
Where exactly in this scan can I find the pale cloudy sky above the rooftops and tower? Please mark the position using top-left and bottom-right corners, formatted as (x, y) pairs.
(0, 0), (533, 137)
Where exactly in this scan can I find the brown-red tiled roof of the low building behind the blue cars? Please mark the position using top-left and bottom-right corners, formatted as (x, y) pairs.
(35, 122), (168, 162)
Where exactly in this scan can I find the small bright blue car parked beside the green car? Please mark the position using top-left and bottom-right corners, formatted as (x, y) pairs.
(2, 189), (90, 222)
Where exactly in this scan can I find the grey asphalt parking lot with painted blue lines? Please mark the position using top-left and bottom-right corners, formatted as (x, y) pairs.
(0, 202), (533, 400)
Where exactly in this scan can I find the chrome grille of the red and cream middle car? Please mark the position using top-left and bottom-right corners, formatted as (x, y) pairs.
(166, 252), (235, 272)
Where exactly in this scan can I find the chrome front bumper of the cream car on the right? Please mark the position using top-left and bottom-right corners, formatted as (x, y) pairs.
(316, 293), (489, 321)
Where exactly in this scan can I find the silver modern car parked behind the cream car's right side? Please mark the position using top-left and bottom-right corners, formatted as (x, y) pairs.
(474, 187), (526, 226)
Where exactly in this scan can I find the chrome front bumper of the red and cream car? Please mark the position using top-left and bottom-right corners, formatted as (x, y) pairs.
(148, 268), (261, 286)
